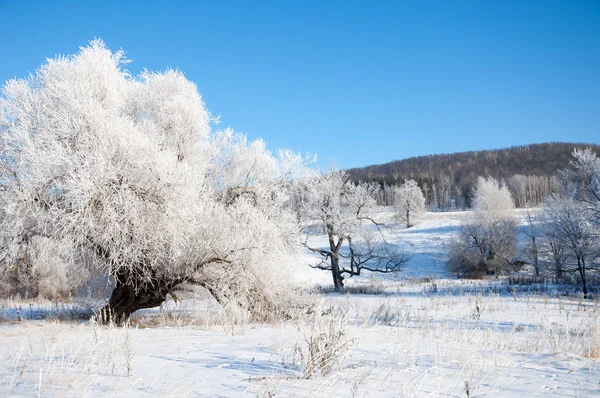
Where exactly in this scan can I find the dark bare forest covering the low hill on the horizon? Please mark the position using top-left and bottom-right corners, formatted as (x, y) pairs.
(347, 142), (600, 210)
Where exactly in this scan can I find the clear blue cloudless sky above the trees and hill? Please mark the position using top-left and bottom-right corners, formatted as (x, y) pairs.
(0, 0), (600, 168)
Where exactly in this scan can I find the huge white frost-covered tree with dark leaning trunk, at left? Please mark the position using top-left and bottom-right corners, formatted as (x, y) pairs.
(0, 40), (306, 324)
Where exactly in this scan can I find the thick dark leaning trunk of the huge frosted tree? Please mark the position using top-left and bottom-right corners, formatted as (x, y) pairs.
(97, 280), (168, 326)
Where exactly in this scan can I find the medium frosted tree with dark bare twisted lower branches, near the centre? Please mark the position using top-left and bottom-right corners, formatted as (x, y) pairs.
(303, 170), (407, 291)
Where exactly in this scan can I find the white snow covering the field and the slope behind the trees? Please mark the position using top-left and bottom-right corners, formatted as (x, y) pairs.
(0, 212), (600, 397)
